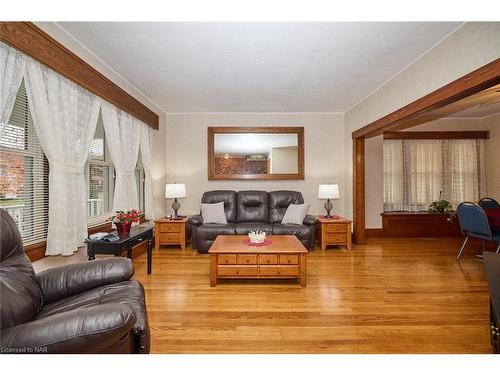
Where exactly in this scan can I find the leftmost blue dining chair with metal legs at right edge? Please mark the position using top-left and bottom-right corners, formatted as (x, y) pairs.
(457, 202), (500, 260)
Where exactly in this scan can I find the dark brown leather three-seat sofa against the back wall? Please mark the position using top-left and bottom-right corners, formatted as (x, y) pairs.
(189, 190), (318, 253)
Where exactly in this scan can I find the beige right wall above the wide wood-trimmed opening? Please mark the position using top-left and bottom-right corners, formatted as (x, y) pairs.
(345, 22), (500, 223)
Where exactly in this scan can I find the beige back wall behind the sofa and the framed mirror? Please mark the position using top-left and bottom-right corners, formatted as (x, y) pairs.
(167, 113), (345, 214)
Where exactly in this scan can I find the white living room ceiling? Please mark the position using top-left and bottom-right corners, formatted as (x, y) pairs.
(58, 22), (460, 113)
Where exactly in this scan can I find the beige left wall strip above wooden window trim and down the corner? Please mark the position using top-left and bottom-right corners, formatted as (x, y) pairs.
(35, 22), (167, 217)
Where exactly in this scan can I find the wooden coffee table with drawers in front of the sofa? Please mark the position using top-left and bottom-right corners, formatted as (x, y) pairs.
(208, 235), (307, 286)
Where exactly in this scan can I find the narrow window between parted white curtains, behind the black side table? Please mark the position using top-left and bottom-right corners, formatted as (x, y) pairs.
(85, 114), (114, 225)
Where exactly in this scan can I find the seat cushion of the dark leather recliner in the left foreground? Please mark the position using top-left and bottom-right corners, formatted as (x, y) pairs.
(35, 280), (149, 353)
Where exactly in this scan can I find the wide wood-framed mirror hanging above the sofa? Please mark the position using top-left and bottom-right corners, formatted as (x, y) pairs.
(208, 127), (304, 180)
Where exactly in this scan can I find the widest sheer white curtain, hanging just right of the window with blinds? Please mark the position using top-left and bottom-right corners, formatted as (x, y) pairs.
(25, 58), (101, 255)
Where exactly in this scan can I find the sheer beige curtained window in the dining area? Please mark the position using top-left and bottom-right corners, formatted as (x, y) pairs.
(384, 139), (485, 212)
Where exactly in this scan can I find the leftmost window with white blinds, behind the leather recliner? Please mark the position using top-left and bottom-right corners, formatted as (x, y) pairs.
(0, 82), (49, 244)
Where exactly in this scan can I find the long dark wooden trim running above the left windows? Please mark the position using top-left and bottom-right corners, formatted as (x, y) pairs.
(0, 22), (159, 129)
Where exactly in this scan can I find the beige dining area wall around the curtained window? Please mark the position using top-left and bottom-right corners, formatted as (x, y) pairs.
(365, 115), (500, 228)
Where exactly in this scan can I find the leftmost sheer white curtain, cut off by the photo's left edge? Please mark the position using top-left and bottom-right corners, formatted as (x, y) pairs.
(0, 42), (26, 136)
